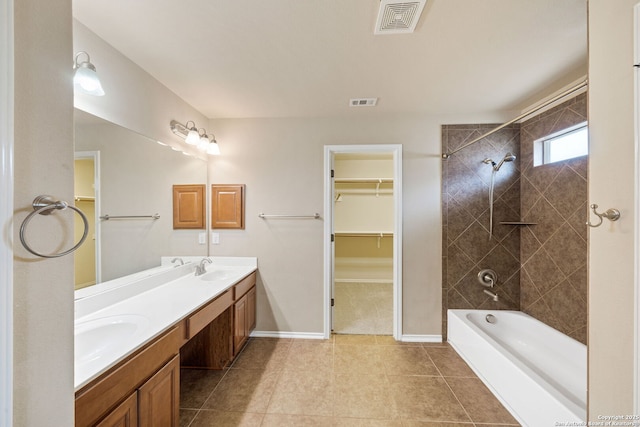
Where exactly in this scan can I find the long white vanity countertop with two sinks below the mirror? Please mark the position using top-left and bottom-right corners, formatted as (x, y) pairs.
(74, 257), (257, 391)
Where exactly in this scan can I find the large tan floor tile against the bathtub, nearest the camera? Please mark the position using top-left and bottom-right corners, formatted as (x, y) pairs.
(446, 377), (517, 424)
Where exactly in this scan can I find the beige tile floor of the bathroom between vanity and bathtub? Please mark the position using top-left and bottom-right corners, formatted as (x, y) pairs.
(180, 335), (519, 427)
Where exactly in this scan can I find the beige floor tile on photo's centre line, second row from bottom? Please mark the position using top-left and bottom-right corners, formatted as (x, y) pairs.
(266, 370), (333, 416)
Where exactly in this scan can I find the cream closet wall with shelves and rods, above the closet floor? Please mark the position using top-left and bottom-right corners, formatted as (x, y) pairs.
(334, 154), (394, 283)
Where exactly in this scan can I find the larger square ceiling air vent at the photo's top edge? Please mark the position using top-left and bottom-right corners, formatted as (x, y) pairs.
(374, 0), (427, 34)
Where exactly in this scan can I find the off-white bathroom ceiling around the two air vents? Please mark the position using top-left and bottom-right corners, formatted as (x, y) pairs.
(73, 0), (587, 118)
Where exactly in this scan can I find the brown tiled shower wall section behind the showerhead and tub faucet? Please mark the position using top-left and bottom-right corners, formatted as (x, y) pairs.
(442, 125), (520, 336)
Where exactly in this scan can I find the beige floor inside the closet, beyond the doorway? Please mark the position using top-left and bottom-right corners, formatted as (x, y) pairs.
(333, 282), (393, 335)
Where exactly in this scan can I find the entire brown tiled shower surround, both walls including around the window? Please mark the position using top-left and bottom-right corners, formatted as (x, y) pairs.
(442, 95), (587, 343)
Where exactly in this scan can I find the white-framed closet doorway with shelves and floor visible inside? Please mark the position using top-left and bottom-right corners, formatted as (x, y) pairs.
(325, 145), (402, 339)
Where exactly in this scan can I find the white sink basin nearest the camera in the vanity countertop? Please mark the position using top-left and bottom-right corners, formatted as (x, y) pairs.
(74, 314), (149, 366)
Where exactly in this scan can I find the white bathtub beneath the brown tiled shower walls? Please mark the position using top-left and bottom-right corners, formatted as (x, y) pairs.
(447, 310), (587, 427)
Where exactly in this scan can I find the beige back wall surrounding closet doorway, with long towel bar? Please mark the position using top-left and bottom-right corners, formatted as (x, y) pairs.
(209, 115), (510, 335)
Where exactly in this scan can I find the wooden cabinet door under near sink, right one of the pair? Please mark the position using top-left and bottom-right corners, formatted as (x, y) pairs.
(138, 356), (180, 427)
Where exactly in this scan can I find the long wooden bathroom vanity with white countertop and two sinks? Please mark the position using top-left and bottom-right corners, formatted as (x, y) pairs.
(75, 257), (257, 427)
